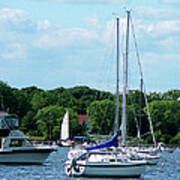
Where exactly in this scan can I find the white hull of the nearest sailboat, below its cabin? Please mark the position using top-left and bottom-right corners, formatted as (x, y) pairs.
(65, 162), (146, 178)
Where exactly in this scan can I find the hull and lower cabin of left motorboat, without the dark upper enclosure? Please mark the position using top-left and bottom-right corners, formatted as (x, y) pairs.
(0, 130), (56, 164)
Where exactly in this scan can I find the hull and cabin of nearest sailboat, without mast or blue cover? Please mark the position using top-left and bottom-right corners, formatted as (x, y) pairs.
(65, 151), (147, 178)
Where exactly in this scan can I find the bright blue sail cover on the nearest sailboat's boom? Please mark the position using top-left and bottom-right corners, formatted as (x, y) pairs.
(86, 132), (118, 151)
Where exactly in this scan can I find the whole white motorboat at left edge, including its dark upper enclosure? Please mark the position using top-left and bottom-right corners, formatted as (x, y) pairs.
(0, 112), (57, 164)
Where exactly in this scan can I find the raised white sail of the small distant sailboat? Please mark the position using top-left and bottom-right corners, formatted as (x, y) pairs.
(61, 111), (69, 140)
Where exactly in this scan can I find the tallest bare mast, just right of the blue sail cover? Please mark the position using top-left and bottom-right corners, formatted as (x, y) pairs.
(121, 11), (130, 146)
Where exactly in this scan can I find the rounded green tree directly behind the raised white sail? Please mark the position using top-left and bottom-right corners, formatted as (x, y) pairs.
(35, 105), (81, 139)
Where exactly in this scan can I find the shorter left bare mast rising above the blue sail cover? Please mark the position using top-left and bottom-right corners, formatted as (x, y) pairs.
(114, 17), (119, 132)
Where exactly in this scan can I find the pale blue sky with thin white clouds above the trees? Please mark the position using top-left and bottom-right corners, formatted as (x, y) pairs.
(0, 0), (180, 92)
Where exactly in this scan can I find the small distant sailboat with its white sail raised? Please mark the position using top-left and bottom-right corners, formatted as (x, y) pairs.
(60, 110), (72, 147)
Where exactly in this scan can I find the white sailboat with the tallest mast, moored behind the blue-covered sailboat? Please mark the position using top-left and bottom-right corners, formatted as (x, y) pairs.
(117, 11), (161, 165)
